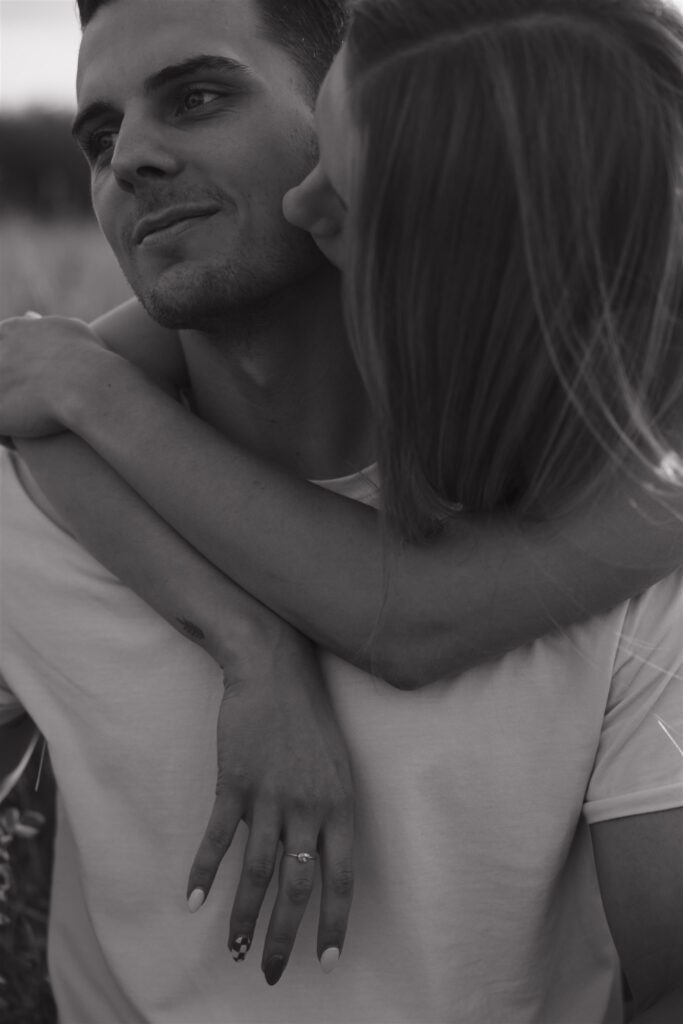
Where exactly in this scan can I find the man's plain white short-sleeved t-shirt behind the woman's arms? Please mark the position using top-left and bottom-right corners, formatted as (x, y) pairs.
(0, 453), (683, 1024)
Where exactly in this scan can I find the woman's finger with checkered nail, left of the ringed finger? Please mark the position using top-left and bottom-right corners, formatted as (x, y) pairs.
(227, 808), (281, 964)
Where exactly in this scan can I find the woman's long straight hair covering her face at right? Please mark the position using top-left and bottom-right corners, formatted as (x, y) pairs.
(346, 0), (683, 539)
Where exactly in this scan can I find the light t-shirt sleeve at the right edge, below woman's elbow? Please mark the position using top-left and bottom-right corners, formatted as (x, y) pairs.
(584, 572), (683, 824)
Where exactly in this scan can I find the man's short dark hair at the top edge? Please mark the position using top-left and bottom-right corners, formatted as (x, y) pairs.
(77, 0), (346, 95)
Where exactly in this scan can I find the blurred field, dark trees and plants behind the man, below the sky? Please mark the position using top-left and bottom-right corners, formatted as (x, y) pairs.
(0, 111), (130, 1024)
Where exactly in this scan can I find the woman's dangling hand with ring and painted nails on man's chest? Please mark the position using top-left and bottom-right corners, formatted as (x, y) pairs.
(187, 616), (353, 985)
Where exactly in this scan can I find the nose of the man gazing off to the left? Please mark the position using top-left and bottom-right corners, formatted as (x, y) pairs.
(112, 117), (181, 190)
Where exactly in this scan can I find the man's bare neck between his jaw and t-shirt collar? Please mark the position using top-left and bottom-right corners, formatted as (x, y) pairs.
(181, 270), (373, 479)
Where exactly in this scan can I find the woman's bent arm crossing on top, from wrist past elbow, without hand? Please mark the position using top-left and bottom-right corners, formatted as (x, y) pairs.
(58, 353), (683, 687)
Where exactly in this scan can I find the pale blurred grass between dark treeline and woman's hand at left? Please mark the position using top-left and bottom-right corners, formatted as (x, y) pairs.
(0, 216), (131, 321)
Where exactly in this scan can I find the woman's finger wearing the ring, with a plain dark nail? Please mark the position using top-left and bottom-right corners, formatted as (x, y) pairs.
(261, 827), (318, 985)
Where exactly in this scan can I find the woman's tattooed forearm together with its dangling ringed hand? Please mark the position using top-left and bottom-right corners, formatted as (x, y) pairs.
(16, 433), (353, 974)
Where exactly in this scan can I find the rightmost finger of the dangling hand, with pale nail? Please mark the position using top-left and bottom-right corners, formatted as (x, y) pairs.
(317, 812), (353, 974)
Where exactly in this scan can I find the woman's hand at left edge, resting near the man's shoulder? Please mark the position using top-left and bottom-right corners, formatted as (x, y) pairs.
(0, 314), (101, 437)
